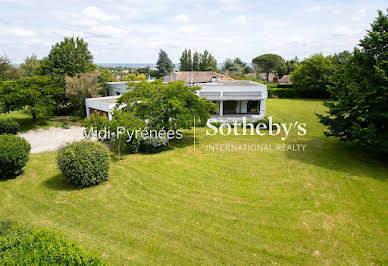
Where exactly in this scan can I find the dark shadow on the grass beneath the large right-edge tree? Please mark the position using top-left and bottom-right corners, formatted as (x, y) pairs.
(284, 138), (388, 180)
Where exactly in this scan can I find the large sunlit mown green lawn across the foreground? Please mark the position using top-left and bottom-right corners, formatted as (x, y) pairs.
(0, 99), (388, 264)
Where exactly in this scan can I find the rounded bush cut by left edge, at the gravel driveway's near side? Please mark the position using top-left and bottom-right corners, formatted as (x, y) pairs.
(0, 135), (31, 179)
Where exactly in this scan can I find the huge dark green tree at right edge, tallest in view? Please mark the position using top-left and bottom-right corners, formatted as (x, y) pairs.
(318, 11), (388, 153)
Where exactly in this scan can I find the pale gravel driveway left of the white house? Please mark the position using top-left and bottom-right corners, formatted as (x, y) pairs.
(18, 126), (83, 153)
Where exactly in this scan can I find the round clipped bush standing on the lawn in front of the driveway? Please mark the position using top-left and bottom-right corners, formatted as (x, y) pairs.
(57, 140), (110, 187)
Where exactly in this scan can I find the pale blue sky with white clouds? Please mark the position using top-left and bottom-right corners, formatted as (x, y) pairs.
(0, 0), (387, 63)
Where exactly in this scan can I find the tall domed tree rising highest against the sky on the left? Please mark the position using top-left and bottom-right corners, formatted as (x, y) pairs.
(39, 37), (95, 77)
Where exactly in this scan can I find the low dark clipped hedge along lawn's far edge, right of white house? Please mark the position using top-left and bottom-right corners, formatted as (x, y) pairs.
(268, 88), (330, 99)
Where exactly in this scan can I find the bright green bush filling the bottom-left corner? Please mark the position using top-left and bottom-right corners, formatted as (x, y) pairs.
(0, 225), (104, 265)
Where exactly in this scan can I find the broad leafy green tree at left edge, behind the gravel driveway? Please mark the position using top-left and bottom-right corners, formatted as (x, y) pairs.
(0, 76), (65, 121)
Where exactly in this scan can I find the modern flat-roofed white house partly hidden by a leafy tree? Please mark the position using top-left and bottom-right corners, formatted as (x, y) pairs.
(85, 80), (268, 122)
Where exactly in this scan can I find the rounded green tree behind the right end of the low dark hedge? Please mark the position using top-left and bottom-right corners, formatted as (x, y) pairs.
(291, 54), (334, 91)
